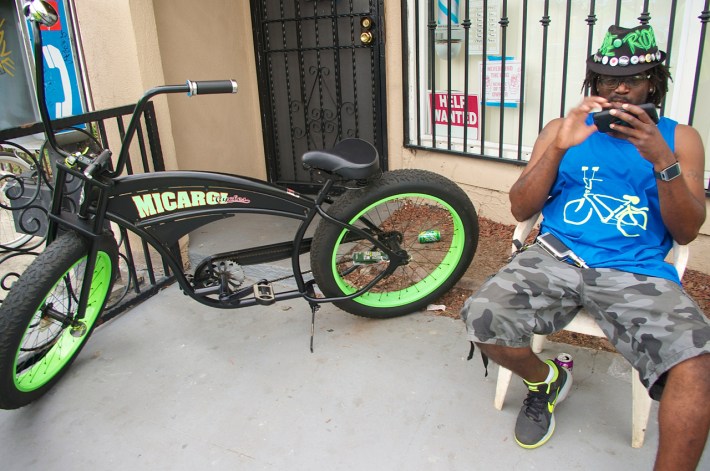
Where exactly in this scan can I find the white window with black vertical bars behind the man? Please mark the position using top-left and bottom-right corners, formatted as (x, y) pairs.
(402, 0), (710, 196)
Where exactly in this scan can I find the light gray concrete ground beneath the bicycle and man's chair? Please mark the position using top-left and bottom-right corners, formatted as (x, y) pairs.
(0, 286), (710, 471)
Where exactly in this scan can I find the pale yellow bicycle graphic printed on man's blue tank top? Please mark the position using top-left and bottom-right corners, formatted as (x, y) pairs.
(564, 166), (648, 237)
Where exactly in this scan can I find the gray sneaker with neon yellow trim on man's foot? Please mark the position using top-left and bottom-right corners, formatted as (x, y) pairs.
(515, 360), (572, 448)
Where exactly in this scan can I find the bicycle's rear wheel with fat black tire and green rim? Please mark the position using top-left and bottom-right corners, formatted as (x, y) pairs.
(311, 169), (478, 319)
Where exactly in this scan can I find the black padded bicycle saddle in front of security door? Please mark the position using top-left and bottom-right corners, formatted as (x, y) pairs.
(303, 138), (380, 180)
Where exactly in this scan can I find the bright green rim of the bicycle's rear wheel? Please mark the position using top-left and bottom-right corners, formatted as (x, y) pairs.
(331, 193), (466, 308)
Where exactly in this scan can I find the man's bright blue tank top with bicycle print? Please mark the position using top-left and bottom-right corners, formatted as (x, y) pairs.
(541, 115), (680, 283)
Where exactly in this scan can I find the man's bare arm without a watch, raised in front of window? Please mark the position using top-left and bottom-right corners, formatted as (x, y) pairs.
(509, 96), (608, 221)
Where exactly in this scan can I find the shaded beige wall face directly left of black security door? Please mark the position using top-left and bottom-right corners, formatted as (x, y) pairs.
(153, 0), (266, 178)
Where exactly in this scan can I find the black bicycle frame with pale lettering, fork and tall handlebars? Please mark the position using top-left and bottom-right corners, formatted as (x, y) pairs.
(28, 1), (407, 319)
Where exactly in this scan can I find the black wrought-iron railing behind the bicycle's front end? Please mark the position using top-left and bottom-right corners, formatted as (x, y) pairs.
(0, 103), (173, 321)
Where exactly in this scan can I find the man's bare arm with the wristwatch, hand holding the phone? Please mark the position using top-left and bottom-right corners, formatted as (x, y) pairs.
(613, 105), (706, 244)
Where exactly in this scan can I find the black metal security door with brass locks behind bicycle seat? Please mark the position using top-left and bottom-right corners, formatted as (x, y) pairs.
(252, 0), (386, 191)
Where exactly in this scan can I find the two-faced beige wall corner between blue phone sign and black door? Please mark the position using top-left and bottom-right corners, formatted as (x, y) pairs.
(75, 0), (266, 178)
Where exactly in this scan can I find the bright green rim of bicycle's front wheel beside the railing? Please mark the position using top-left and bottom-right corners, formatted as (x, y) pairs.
(14, 252), (111, 392)
